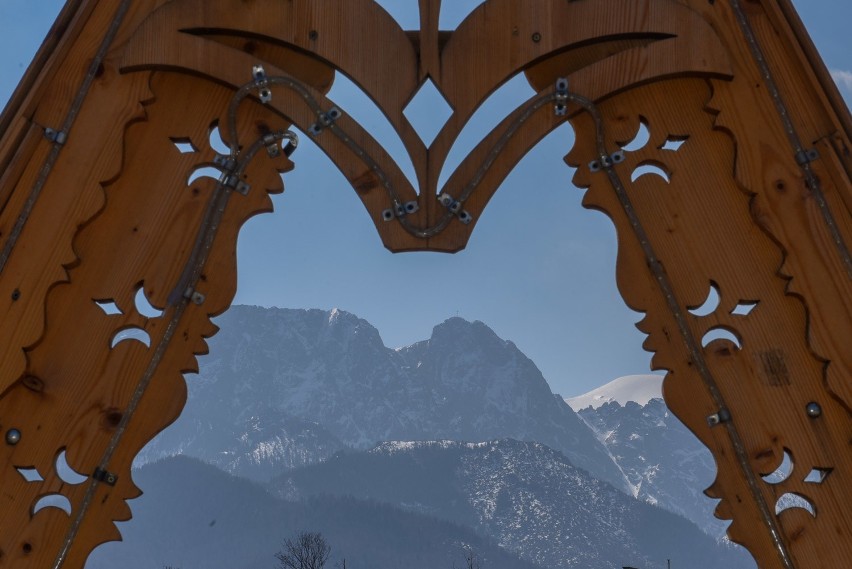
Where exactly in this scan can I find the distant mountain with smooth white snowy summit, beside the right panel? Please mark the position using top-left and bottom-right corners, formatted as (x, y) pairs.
(567, 376), (730, 538)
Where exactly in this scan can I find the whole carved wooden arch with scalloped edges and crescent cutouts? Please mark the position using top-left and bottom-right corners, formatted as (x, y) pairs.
(0, 0), (852, 569)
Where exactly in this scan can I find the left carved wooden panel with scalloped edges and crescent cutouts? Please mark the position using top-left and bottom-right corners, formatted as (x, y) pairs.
(0, 69), (291, 568)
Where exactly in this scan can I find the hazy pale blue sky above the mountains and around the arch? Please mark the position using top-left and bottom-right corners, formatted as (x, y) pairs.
(0, 0), (852, 396)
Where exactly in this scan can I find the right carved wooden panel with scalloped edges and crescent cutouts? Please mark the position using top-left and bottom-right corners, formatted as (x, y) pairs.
(569, 80), (852, 567)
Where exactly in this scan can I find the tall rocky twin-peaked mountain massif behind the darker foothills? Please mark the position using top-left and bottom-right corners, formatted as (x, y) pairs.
(138, 306), (629, 491)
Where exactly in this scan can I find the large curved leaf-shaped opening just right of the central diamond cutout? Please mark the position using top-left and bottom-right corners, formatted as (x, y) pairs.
(438, 73), (536, 189)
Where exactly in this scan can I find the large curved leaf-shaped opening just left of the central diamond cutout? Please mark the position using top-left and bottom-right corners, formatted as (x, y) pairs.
(324, 71), (418, 190)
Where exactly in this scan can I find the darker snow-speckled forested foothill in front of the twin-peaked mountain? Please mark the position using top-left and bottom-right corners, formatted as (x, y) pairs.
(272, 439), (754, 569)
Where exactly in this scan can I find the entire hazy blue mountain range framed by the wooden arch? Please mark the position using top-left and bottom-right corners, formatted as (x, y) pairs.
(115, 306), (754, 569)
